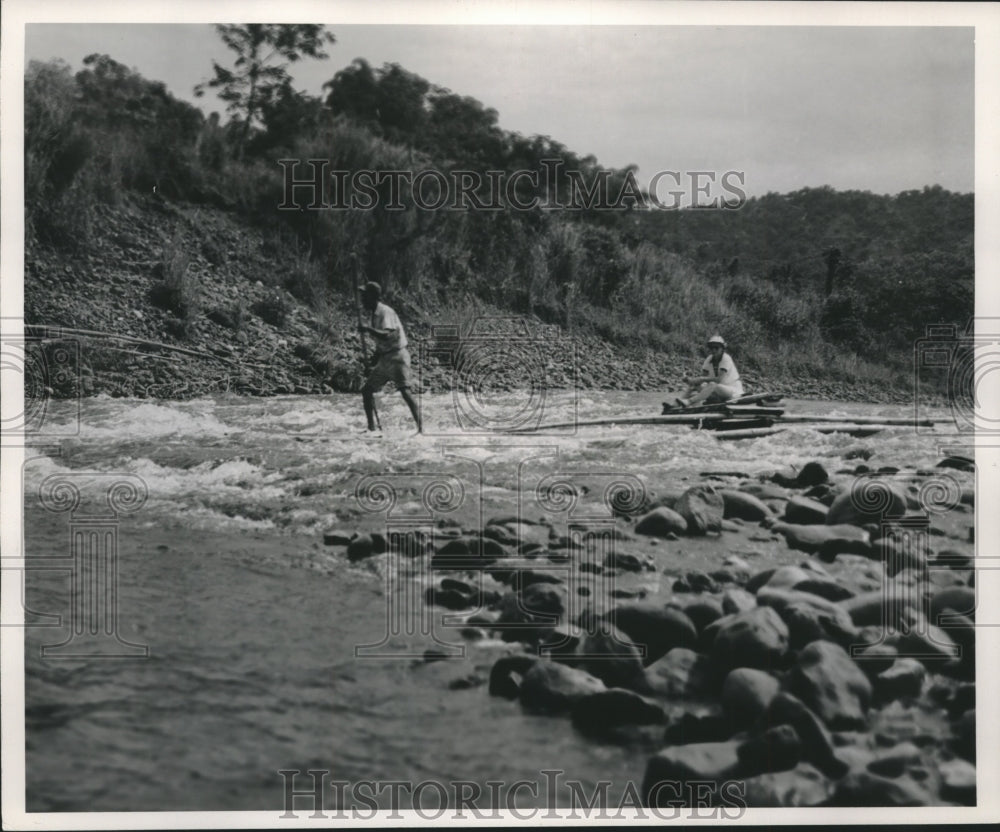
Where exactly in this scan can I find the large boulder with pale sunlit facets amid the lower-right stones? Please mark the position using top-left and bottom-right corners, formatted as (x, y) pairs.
(785, 641), (872, 730)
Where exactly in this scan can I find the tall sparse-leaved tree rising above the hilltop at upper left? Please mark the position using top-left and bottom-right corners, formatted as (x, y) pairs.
(194, 23), (336, 157)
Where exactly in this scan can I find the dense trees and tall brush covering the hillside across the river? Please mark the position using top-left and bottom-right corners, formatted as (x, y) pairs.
(25, 35), (974, 390)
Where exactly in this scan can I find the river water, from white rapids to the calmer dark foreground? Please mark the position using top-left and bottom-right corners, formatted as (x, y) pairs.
(17, 393), (960, 811)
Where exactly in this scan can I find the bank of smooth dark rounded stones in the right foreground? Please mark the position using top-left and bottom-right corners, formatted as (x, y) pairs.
(325, 447), (977, 810)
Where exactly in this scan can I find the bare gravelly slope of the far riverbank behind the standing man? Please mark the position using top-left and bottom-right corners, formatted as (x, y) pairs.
(25, 196), (912, 402)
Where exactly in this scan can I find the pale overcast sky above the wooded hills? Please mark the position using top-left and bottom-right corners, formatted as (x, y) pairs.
(25, 24), (975, 195)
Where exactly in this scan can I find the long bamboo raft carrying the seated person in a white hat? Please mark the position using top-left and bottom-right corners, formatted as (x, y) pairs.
(508, 393), (934, 440)
